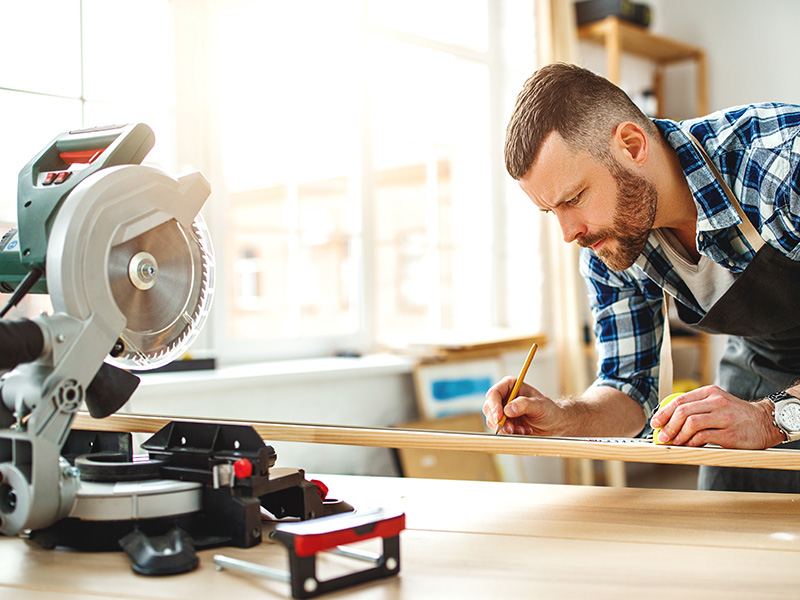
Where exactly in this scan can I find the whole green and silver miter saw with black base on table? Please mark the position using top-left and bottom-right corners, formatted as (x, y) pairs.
(0, 124), (360, 574)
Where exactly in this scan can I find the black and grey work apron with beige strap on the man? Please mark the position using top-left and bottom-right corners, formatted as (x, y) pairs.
(676, 141), (800, 493)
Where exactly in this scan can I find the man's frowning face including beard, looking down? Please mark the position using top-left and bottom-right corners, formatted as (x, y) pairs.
(519, 133), (658, 271)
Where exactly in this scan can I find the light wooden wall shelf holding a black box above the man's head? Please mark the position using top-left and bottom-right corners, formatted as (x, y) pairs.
(578, 17), (708, 117)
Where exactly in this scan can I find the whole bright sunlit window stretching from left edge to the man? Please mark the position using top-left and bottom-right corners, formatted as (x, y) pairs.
(0, 0), (539, 362)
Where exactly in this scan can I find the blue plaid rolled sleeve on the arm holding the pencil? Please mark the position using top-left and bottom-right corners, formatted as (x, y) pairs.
(580, 248), (664, 428)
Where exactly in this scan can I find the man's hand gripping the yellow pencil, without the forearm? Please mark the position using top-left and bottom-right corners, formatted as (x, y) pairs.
(483, 377), (565, 435)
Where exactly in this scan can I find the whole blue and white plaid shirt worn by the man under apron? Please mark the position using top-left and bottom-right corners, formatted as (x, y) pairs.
(581, 104), (800, 427)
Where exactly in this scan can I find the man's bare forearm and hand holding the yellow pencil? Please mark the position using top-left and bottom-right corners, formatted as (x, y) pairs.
(483, 377), (646, 437)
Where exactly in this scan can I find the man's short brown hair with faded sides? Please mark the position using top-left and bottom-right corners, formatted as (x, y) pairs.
(505, 63), (658, 180)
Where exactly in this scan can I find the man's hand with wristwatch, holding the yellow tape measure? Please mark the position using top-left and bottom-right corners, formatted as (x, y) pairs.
(650, 385), (781, 450)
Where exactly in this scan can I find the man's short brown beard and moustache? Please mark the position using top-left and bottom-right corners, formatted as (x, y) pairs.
(578, 162), (658, 271)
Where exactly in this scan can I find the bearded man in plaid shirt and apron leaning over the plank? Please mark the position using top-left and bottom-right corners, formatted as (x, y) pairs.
(484, 64), (800, 493)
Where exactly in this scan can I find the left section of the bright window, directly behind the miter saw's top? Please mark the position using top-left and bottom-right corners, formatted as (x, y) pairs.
(0, 0), (175, 324)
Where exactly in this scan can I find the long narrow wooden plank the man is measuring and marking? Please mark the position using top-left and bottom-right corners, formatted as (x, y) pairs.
(73, 413), (800, 470)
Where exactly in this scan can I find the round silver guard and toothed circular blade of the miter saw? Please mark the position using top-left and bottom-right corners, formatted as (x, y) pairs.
(47, 165), (215, 370)
